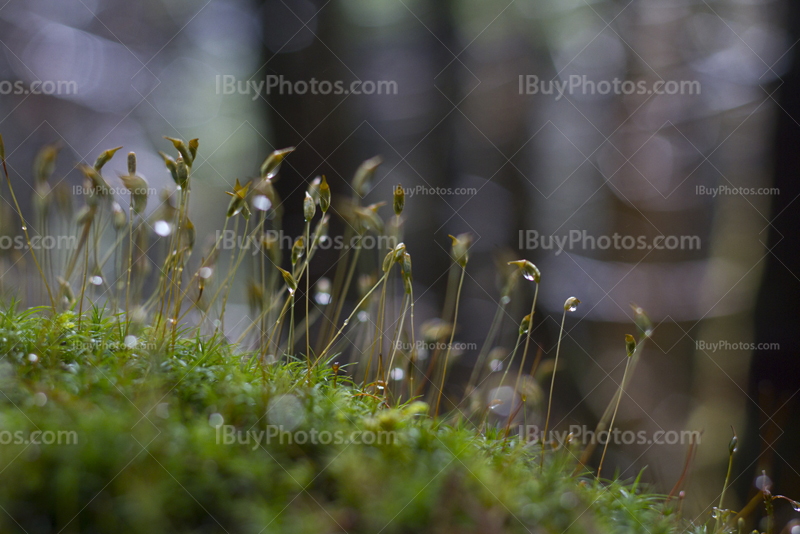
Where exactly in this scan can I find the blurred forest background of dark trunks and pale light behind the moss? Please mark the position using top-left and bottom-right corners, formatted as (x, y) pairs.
(0, 0), (800, 519)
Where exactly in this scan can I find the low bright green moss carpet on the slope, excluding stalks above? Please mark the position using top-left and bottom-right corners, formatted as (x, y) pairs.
(0, 307), (683, 534)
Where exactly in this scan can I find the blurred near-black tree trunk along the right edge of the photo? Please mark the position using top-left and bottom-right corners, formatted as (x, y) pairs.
(738, 2), (800, 524)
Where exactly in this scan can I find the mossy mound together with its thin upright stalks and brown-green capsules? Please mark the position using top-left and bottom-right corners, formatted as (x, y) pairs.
(0, 137), (781, 534)
